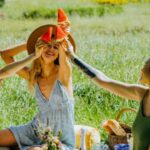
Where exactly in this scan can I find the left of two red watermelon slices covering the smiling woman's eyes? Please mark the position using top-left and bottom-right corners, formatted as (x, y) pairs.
(40, 27), (52, 43)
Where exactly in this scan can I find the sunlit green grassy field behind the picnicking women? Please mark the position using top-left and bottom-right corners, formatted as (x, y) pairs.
(0, 0), (150, 139)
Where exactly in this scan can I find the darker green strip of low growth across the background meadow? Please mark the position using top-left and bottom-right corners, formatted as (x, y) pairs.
(21, 5), (123, 19)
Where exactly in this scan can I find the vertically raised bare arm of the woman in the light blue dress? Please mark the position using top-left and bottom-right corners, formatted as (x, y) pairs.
(58, 42), (73, 97)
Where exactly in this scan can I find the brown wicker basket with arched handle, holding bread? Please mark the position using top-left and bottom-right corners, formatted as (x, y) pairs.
(108, 108), (136, 150)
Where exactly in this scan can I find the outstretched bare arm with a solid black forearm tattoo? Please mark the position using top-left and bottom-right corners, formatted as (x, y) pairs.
(69, 52), (148, 100)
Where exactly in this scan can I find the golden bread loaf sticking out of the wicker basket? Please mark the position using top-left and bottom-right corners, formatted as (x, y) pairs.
(103, 119), (126, 136)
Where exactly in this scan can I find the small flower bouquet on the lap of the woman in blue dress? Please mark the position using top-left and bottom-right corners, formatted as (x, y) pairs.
(39, 127), (62, 150)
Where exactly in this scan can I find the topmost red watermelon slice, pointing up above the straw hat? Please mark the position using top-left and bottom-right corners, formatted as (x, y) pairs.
(58, 8), (70, 34)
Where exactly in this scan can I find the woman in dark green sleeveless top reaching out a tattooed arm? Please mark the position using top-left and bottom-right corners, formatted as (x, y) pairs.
(68, 42), (150, 150)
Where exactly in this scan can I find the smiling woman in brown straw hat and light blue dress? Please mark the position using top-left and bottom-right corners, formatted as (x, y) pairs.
(0, 9), (75, 150)
